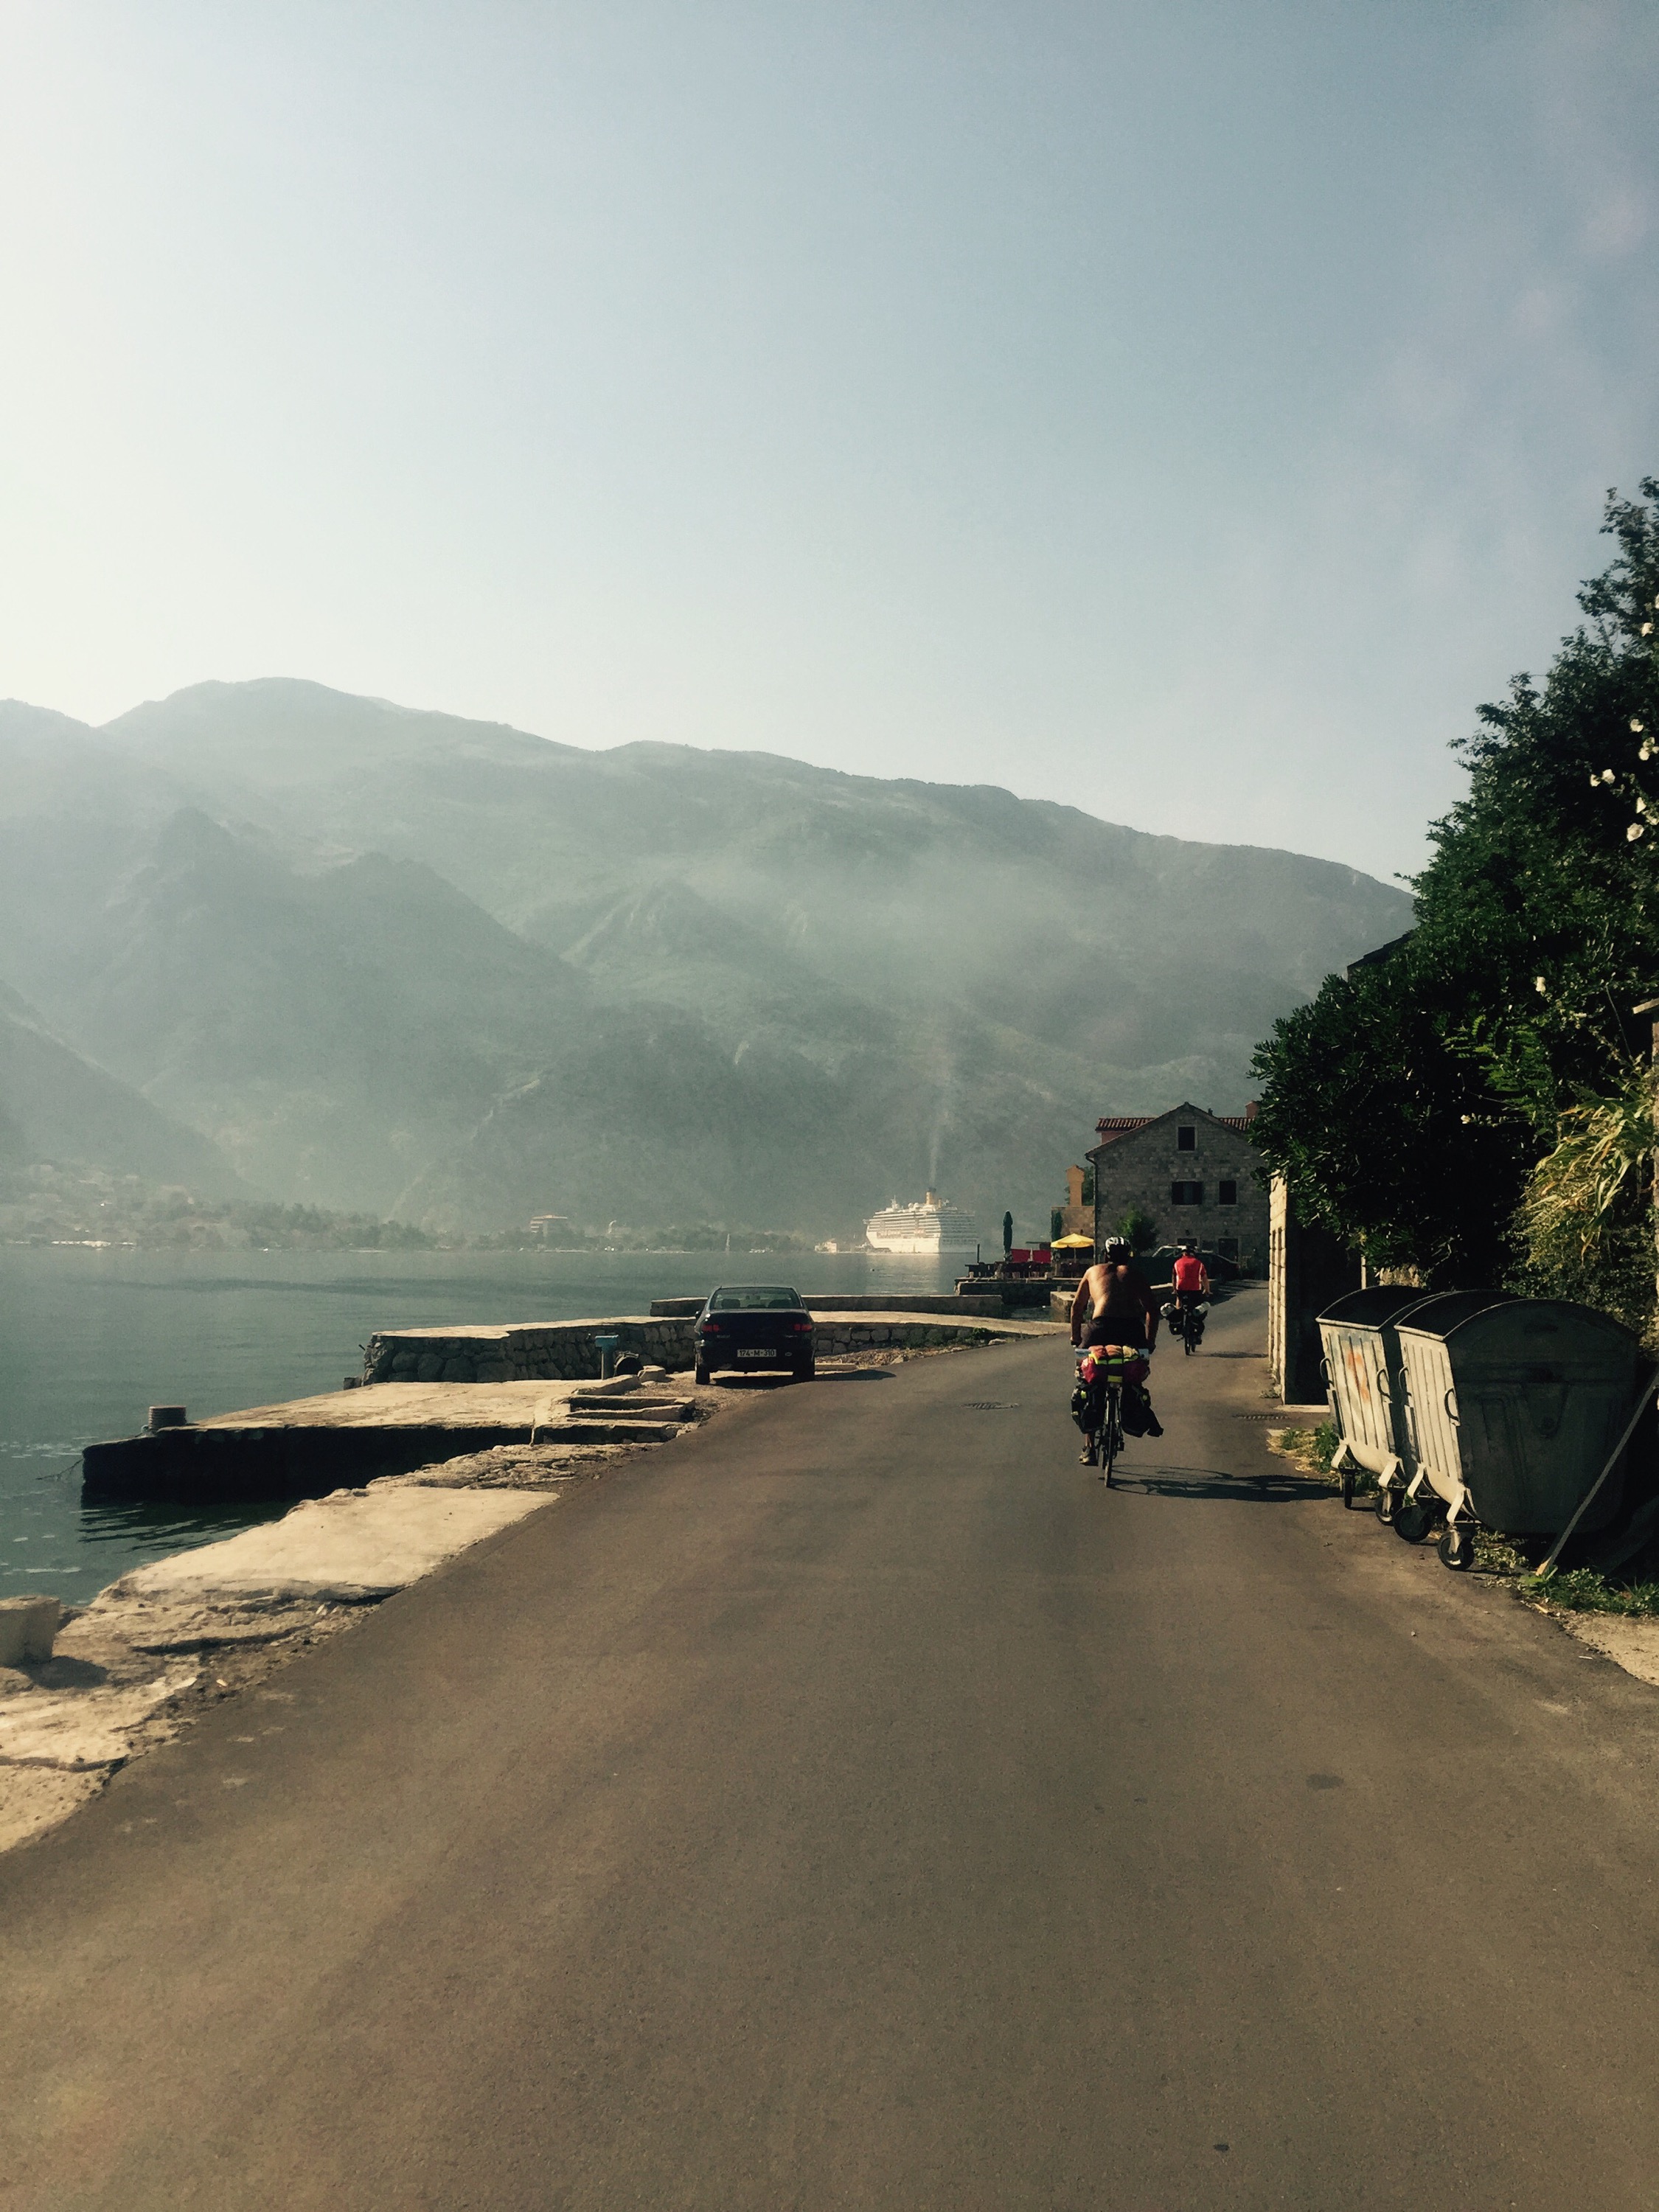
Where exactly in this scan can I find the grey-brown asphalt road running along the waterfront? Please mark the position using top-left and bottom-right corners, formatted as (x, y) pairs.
(0, 1294), (1659, 2212)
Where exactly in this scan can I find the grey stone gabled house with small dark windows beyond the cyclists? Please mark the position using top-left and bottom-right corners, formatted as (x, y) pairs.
(1088, 1106), (1267, 1274)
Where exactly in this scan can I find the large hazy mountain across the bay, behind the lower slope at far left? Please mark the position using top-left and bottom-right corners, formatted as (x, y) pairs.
(0, 679), (1409, 1234)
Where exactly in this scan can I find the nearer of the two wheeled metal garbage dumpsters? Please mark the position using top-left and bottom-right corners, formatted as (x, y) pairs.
(1396, 1290), (1644, 1566)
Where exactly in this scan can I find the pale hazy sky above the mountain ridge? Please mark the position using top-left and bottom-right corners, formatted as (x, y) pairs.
(0, 0), (1659, 874)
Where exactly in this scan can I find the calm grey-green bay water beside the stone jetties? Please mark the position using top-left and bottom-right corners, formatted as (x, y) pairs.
(0, 1245), (956, 1601)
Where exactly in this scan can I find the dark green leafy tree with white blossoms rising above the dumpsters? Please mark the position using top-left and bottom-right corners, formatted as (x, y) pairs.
(1254, 478), (1659, 1285)
